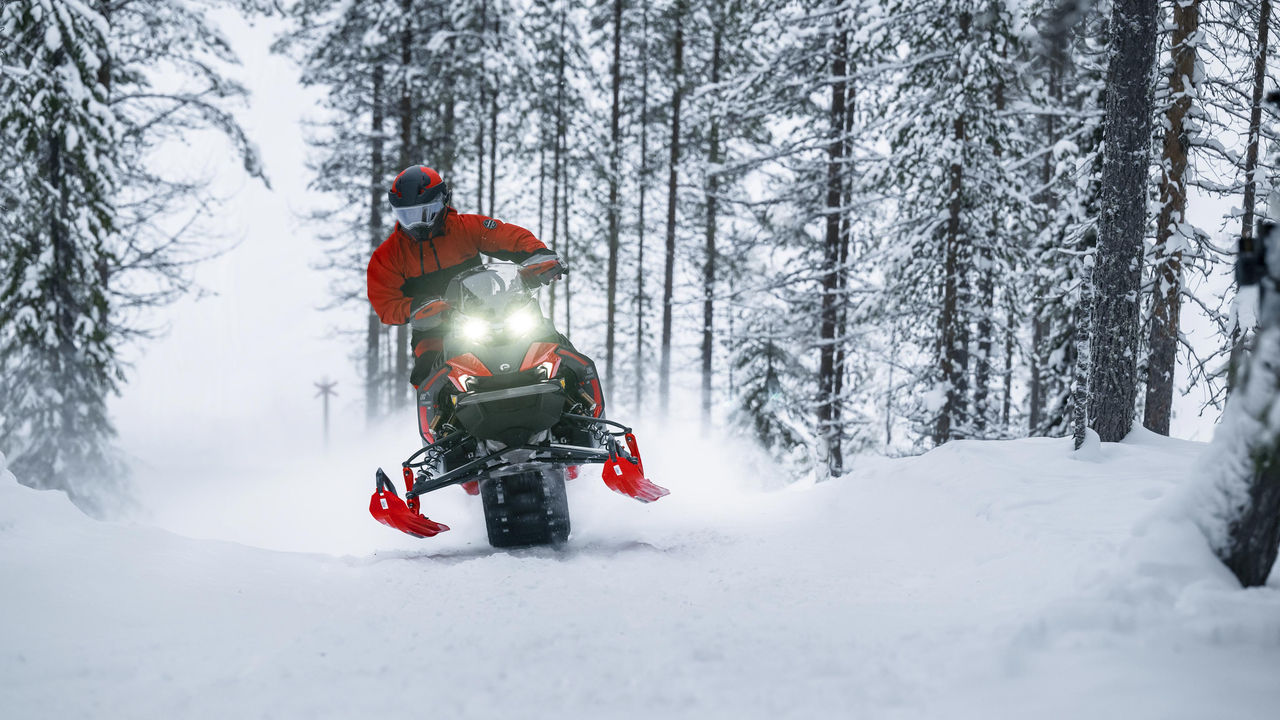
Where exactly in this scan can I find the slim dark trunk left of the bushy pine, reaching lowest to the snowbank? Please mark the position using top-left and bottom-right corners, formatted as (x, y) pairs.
(818, 17), (849, 477)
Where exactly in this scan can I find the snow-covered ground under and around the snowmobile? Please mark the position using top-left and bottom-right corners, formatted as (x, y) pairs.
(0, 432), (1280, 720)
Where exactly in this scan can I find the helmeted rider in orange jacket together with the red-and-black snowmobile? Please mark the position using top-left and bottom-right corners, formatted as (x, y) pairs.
(369, 165), (668, 547)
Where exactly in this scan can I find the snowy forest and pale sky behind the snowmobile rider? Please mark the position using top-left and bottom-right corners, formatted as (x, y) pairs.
(0, 0), (1276, 507)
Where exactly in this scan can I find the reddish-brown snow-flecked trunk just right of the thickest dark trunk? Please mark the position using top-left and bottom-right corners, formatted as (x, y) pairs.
(1142, 0), (1201, 436)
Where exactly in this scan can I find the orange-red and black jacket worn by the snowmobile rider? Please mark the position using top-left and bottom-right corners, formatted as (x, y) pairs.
(369, 208), (550, 325)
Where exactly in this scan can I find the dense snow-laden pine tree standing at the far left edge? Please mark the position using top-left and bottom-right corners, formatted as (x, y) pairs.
(0, 1), (122, 509)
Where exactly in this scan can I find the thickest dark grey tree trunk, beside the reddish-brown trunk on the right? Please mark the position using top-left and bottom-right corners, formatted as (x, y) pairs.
(1089, 0), (1158, 442)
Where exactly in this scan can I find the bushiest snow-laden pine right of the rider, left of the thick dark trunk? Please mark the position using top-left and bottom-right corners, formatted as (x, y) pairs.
(860, 3), (1032, 442)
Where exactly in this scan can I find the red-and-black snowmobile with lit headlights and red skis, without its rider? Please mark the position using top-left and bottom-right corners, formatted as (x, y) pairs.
(369, 263), (668, 547)
